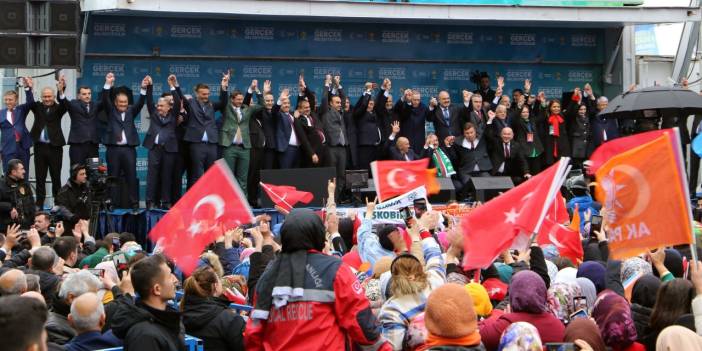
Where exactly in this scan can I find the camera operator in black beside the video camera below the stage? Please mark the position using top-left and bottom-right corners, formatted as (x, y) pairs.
(56, 164), (92, 224)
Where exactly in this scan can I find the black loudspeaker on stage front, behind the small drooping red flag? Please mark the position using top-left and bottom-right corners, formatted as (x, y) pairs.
(262, 167), (336, 208)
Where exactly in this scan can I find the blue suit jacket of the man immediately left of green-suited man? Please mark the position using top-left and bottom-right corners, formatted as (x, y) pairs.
(176, 87), (228, 144)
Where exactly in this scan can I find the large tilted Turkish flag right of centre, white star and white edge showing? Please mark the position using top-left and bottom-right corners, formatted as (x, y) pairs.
(461, 158), (568, 270)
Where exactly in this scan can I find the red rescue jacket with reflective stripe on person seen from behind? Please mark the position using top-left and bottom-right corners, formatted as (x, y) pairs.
(245, 252), (392, 351)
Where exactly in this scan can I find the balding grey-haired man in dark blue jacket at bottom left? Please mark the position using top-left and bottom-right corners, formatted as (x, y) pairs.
(65, 292), (122, 351)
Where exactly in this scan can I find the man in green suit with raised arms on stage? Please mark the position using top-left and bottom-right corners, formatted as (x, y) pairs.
(219, 80), (263, 195)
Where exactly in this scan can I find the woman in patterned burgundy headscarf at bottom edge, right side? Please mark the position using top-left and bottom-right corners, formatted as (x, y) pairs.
(592, 290), (646, 351)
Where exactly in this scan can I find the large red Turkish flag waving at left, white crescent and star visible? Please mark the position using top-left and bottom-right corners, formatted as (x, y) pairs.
(149, 160), (253, 275)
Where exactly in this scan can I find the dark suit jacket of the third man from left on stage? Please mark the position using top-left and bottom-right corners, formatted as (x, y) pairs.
(58, 92), (104, 144)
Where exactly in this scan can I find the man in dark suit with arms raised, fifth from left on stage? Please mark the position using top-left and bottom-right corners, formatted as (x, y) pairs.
(144, 75), (181, 210)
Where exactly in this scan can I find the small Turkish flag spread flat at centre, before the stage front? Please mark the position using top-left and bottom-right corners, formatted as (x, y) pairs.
(371, 158), (441, 202)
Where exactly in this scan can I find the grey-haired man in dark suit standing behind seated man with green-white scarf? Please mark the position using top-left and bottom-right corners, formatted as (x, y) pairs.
(429, 90), (468, 140)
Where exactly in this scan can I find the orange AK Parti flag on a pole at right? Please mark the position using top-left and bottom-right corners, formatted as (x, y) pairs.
(596, 130), (693, 259)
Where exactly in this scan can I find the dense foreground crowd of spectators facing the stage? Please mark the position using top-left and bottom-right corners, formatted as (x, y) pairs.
(0, 172), (702, 351)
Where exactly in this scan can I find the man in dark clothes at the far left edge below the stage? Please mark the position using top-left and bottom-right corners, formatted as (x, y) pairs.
(0, 159), (36, 232)
